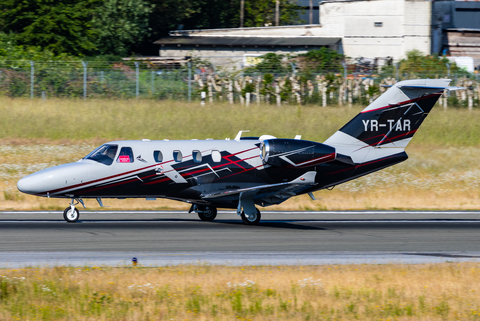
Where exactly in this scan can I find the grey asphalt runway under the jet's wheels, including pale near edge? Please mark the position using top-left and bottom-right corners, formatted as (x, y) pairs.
(0, 211), (480, 267)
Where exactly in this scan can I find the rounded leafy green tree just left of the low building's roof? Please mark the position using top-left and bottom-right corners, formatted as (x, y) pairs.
(92, 0), (153, 56)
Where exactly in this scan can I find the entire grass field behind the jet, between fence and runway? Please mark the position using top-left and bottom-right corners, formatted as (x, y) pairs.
(0, 98), (480, 210)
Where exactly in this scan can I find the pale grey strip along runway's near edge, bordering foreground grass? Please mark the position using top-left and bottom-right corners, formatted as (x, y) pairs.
(0, 251), (480, 268)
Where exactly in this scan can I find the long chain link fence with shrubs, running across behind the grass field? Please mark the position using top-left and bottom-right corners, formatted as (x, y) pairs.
(0, 61), (480, 108)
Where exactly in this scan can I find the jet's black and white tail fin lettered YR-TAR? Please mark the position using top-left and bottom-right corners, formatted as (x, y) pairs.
(324, 79), (451, 163)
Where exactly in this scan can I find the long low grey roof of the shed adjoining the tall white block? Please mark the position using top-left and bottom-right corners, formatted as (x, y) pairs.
(154, 36), (341, 47)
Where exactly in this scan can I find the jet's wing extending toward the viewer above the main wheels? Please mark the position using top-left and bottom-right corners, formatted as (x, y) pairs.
(202, 171), (317, 204)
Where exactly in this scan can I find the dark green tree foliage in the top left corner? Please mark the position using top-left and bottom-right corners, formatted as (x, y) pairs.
(0, 0), (100, 55)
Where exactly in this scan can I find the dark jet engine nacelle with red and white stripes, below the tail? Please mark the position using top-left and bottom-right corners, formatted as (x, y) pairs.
(260, 139), (336, 167)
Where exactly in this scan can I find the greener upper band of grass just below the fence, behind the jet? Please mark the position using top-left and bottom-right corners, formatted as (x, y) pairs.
(0, 98), (480, 146)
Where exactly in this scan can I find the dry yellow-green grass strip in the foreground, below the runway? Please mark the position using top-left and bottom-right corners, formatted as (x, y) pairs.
(0, 263), (480, 321)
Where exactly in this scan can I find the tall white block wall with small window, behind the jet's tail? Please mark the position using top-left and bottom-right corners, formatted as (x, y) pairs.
(320, 0), (431, 60)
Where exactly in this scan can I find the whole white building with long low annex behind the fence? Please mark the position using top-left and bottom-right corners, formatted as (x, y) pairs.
(155, 0), (480, 67)
